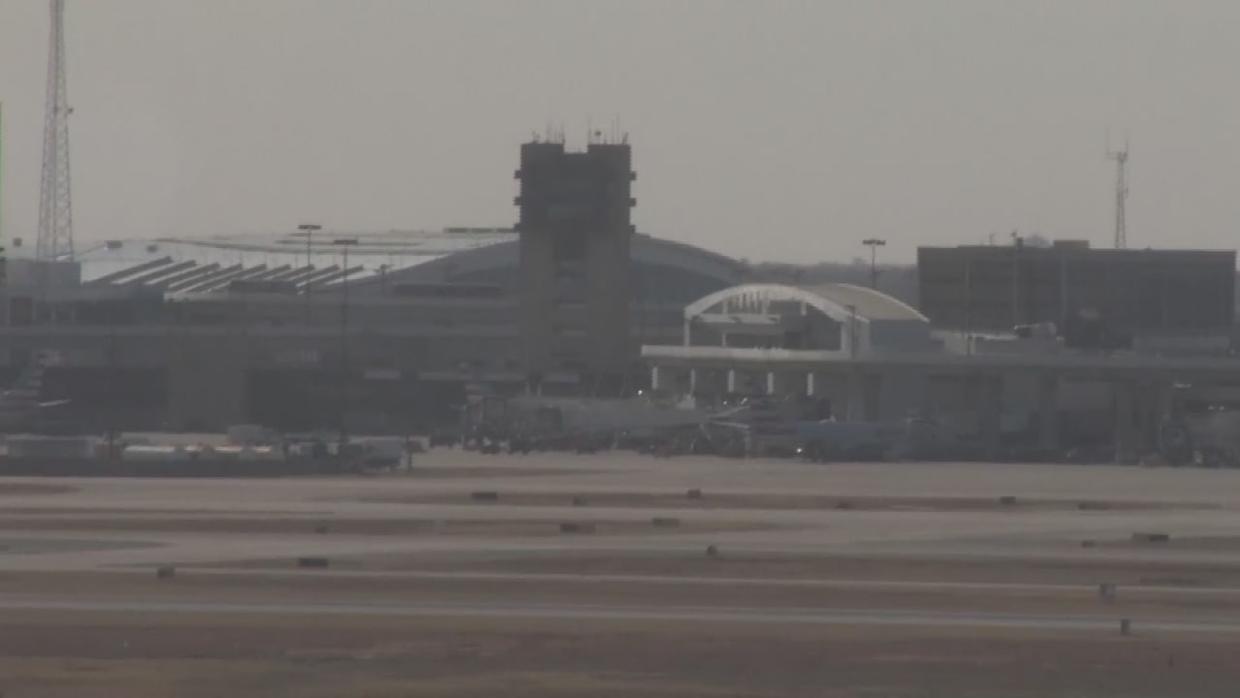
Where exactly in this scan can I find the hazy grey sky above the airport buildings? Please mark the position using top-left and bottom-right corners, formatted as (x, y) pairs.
(0, 0), (1240, 262)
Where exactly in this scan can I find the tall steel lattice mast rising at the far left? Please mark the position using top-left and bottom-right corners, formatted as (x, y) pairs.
(36, 0), (73, 259)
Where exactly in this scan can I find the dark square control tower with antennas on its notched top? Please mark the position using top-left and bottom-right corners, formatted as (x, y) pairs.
(516, 141), (636, 395)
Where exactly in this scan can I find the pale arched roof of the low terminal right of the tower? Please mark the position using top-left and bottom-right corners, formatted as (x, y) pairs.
(684, 284), (929, 322)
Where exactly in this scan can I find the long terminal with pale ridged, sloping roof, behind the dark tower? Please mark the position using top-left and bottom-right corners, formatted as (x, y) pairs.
(0, 218), (740, 430)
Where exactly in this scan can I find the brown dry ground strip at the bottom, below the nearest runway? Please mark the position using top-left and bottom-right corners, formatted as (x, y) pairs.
(9, 615), (1240, 698)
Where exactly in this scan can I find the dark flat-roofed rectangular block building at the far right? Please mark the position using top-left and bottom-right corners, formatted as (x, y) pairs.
(918, 239), (1236, 348)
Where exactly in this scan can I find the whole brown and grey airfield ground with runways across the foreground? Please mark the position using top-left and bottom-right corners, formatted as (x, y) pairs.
(0, 451), (1240, 698)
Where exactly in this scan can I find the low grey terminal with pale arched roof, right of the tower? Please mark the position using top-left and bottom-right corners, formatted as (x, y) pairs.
(642, 248), (1240, 459)
